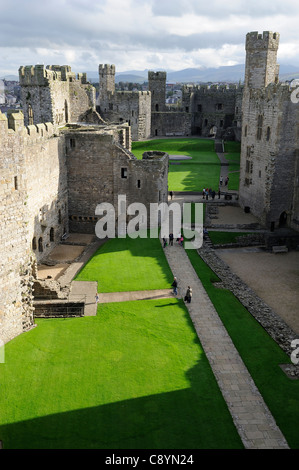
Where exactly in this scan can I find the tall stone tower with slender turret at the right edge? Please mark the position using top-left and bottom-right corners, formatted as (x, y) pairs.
(239, 32), (299, 231)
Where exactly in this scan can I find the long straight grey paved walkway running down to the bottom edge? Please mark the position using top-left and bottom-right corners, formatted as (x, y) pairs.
(165, 237), (288, 449)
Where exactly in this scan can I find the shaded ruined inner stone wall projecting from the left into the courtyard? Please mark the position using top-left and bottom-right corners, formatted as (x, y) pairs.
(65, 126), (168, 233)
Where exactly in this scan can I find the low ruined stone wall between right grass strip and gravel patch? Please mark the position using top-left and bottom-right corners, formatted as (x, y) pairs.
(198, 245), (299, 378)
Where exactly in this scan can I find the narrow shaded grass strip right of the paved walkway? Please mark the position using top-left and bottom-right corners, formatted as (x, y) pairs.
(186, 250), (299, 449)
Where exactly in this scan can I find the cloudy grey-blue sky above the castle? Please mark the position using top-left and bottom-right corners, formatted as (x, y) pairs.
(0, 0), (299, 76)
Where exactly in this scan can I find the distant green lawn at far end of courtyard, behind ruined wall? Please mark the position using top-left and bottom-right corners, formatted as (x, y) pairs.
(132, 138), (220, 192)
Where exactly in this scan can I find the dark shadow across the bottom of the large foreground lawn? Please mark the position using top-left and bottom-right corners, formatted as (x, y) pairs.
(0, 361), (243, 449)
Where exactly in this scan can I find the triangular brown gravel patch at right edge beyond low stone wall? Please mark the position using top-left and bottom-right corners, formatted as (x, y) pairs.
(217, 249), (299, 335)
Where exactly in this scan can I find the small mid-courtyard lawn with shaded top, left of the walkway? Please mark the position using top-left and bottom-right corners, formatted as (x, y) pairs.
(76, 237), (173, 292)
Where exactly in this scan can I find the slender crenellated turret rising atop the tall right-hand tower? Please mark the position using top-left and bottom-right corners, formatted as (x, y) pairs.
(245, 31), (279, 88)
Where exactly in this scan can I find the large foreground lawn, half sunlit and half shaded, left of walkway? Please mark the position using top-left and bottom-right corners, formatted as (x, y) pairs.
(0, 299), (242, 449)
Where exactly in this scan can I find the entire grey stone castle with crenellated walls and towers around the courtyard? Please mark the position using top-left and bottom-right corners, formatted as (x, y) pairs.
(0, 32), (299, 342)
